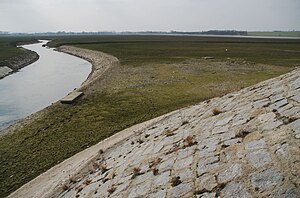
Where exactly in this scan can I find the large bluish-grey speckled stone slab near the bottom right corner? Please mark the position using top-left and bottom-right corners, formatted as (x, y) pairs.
(251, 168), (284, 192)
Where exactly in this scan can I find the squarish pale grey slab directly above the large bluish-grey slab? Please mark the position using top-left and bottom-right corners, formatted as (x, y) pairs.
(248, 149), (272, 168)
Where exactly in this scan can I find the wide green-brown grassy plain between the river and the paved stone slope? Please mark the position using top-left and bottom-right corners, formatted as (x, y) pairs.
(0, 36), (300, 197)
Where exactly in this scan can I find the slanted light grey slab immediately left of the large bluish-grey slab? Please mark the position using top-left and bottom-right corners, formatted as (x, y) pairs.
(217, 164), (242, 183)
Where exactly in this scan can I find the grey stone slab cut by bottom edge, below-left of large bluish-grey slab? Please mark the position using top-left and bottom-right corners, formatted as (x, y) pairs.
(221, 182), (252, 198)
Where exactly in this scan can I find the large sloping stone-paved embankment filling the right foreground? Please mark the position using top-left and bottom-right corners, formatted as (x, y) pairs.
(11, 69), (300, 198)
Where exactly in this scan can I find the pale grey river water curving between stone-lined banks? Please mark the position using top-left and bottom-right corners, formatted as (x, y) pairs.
(0, 41), (92, 131)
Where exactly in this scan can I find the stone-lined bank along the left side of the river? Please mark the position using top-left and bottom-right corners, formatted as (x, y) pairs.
(0, 49), (39, 79)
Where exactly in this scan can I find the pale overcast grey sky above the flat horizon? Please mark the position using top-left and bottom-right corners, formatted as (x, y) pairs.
(0, 0), (300, 32)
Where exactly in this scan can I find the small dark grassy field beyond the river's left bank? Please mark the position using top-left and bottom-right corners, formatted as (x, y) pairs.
(0, 36), (37, 67)
